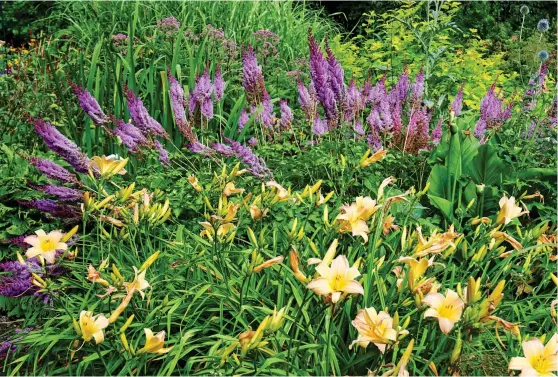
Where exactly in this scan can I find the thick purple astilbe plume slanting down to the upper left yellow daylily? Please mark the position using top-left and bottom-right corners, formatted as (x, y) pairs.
(30, 118), (89, 173)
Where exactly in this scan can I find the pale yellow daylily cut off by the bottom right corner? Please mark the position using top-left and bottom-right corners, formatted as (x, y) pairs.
(508, 334), (558, 376)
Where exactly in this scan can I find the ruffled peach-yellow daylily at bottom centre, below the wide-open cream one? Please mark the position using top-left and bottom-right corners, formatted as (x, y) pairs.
(349, 308), (397, 353)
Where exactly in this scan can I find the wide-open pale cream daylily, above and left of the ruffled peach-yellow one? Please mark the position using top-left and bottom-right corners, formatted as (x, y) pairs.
(306, 255), (364, 304)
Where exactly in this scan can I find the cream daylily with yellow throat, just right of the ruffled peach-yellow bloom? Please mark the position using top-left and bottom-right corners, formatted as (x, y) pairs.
(423, 289), (465, 334)
